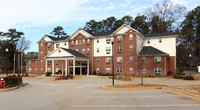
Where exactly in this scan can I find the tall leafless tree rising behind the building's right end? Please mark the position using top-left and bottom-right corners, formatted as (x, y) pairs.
(144, 0), (186, 33)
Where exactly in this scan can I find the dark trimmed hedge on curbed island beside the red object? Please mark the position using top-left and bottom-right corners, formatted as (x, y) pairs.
(4, 76), (22, 87)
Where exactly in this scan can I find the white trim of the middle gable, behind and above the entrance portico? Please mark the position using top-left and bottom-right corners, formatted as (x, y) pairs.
(68, 28), (93, 39)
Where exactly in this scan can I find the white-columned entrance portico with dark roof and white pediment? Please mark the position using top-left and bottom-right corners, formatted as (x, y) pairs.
(44, 48), (89, 76)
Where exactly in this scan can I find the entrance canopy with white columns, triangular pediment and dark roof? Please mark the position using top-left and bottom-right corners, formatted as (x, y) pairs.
(44, 48), (90, 76)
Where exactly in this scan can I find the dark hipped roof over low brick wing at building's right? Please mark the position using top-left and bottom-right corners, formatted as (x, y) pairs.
(139, 46), (168, 56)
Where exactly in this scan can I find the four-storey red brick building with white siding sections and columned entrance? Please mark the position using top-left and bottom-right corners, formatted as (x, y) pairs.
(26, 24), (177, 76)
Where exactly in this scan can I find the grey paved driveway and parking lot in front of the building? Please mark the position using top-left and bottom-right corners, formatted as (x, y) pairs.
(0, 77), (200, 110)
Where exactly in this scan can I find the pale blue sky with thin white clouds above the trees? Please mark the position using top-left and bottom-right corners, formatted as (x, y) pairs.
(0, 0), (200, 52)
